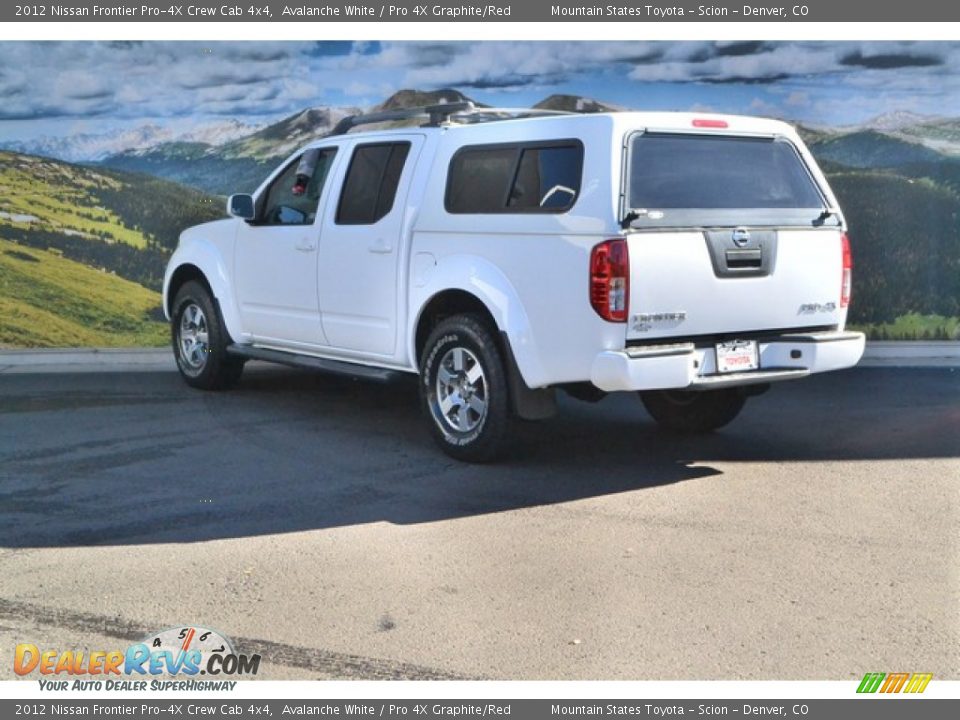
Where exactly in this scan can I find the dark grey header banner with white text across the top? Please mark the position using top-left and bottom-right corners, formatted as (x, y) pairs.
(0, 0), (960, 23)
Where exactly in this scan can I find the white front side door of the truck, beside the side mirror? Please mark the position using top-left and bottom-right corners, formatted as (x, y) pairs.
(234, 146), (337, 348)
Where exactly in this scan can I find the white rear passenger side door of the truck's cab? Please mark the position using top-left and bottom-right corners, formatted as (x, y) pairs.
(319, 134), (423, 356)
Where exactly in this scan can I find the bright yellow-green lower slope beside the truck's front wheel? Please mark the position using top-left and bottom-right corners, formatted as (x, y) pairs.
(0, 240), (169, 348)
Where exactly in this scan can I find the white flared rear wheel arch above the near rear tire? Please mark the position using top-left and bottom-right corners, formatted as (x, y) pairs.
(407, 255), (546, 388)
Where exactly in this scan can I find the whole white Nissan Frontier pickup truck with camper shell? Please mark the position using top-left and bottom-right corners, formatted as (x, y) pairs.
(163, 103), (864, 461)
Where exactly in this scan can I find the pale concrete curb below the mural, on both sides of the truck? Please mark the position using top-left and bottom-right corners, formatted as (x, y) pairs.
(0, 342), (960, 375)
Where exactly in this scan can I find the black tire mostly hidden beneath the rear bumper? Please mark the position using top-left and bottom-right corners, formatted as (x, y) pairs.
(640, 388), (747, 433)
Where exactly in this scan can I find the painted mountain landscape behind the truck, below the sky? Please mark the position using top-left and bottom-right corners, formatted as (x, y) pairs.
(0, 89), (960, 346)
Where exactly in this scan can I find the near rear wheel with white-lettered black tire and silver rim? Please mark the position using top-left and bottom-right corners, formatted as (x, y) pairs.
(420, 315), (511, 463)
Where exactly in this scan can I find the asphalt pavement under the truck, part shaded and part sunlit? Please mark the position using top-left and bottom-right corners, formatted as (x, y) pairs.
(0, 367), (960, 680)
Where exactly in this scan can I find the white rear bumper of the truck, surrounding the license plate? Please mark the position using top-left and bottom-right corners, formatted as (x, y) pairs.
(590, 332), (865, 392)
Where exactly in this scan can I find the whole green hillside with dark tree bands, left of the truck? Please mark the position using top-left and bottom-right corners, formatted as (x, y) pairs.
(0, 152), (222, 347)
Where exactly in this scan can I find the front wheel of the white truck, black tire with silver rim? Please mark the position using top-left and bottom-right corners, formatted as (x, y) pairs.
(170, 280), (244, 390)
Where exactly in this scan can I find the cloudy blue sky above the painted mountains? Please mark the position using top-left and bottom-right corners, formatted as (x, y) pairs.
(0, 41), (960, 141)
